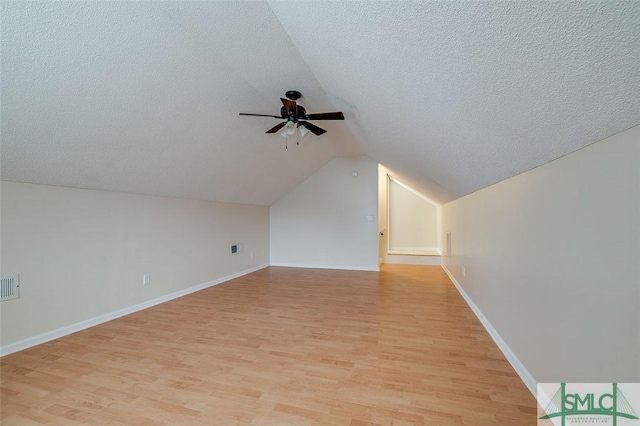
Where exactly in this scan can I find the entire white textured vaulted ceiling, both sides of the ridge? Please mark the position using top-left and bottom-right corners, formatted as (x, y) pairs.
(1, 1), (640, 205)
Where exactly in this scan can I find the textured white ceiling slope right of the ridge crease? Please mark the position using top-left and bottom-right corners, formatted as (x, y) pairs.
(270, 1), (640, 202)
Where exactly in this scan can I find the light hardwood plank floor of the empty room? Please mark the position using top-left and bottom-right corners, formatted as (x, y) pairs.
(0, 265), (536, 426)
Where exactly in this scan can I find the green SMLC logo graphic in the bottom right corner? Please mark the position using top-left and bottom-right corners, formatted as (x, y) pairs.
(540, 383), (639, 426)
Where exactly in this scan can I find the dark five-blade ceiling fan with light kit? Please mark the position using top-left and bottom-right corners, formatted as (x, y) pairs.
(240, 90), (344, 137)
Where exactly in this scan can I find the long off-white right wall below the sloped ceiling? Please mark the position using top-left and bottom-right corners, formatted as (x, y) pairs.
(442, 127), (640, 382)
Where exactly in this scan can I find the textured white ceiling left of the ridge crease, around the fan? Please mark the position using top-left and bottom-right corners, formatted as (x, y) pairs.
(2, 2), (362, 205)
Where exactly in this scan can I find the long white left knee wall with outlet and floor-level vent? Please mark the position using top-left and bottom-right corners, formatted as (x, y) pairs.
(0, 182), (269, 352)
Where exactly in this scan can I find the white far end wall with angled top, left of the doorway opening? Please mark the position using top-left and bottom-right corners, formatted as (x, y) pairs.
(270, 156), (378, 271)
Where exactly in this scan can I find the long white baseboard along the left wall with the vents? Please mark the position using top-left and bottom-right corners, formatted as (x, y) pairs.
(0, 264), (269, 357)
